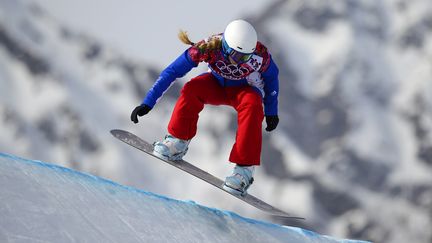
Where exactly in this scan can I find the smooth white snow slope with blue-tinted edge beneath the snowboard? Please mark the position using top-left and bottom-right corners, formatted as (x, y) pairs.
(0, 153), (363, 243)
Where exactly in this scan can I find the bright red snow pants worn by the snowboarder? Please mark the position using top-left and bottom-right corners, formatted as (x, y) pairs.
(168, 73), (264, 165)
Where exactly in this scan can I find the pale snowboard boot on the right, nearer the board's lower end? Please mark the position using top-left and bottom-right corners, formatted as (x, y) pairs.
(223, 165), (255, 196)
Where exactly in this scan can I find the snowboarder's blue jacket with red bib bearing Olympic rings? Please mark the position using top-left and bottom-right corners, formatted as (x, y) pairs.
(142, 38), (279, 115)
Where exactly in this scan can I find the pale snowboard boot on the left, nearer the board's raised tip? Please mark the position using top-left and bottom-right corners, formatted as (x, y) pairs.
(153, 134), (190, 161)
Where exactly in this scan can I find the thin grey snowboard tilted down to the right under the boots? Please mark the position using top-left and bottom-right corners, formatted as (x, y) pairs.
(111, 129), (304, 219)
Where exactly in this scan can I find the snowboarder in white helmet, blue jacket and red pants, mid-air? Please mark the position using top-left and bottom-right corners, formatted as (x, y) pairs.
(131, 20), (279, 195)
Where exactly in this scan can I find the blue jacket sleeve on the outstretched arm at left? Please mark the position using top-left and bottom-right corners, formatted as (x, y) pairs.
(142, 49), (198, 107)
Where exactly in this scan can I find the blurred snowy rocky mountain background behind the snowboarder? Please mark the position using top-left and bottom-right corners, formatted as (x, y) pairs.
(0, 0), (432, 243)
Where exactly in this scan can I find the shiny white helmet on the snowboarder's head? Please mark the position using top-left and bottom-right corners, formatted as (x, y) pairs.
(223, 19), (258, 54)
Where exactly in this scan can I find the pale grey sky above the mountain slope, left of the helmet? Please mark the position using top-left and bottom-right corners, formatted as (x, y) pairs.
(32, 0), (274, 66)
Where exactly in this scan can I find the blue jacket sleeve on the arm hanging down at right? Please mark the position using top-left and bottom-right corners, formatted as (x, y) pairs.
(261, 59), (279, 116)
